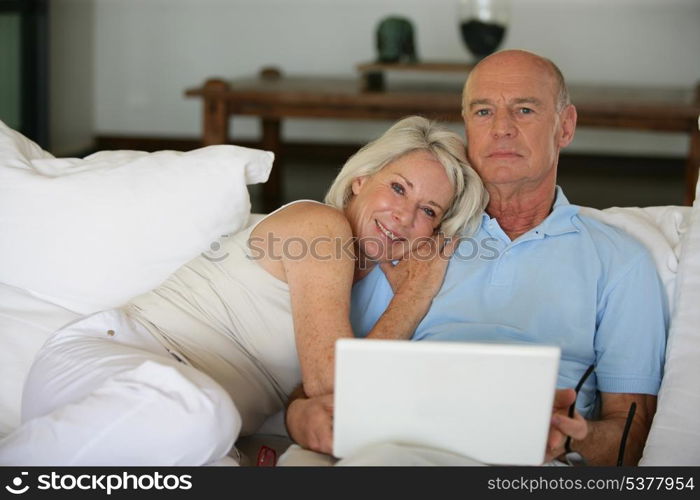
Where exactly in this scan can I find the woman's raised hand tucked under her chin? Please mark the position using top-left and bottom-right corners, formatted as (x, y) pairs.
(380, 233), (459, 299)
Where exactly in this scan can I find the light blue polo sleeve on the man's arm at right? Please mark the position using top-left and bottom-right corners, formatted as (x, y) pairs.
(594, 249), (668, 395)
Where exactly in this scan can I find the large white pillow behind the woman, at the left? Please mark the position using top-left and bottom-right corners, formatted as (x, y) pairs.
(0, 122), (273, 314)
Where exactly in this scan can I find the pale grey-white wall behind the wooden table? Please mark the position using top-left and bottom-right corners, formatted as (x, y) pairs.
(54, 0), (700, 156)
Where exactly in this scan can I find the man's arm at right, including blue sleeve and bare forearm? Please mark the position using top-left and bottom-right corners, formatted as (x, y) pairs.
(572, 242), (668, 465)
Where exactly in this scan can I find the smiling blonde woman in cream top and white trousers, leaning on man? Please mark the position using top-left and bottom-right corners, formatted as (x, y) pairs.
(0, 117), (486, 465)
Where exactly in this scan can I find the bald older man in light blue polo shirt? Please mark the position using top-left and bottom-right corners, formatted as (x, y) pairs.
(280, 50), (668, 465)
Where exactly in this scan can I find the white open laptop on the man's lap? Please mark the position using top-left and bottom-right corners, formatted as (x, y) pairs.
(333, 339), (560, 465)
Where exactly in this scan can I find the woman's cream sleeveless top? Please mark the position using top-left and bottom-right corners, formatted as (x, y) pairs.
(124, 200), (318, 435)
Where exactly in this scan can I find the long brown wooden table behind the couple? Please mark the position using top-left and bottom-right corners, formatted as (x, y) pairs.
(186, 70), (700, 210)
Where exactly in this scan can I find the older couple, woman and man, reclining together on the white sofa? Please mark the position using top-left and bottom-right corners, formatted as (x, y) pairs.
(0, 51), (667, 465)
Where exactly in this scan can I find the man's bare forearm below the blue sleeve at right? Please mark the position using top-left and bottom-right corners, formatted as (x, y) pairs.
(571, 393), (656, 465)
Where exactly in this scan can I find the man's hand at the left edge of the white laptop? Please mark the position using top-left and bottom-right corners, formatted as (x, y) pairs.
(285, 394), (333, 455)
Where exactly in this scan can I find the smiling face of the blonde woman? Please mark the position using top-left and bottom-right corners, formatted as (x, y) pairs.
(346, 151), (454, 261)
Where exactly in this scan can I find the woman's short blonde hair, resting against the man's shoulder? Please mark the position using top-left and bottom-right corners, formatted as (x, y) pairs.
(324, 116), (488, 236)
